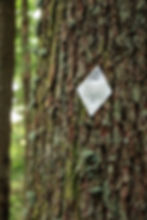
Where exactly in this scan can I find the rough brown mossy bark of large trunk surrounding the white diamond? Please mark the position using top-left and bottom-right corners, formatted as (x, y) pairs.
(26, 0), (147, 220)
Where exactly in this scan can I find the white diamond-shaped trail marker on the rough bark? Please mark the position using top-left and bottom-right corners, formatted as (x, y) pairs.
(77, 66), (112, 116)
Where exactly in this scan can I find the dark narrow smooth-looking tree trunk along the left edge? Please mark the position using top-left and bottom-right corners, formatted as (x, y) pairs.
(0, 0), (15, 220)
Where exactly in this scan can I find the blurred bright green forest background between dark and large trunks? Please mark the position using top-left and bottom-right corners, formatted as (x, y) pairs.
(10, 0), (41, 220)
